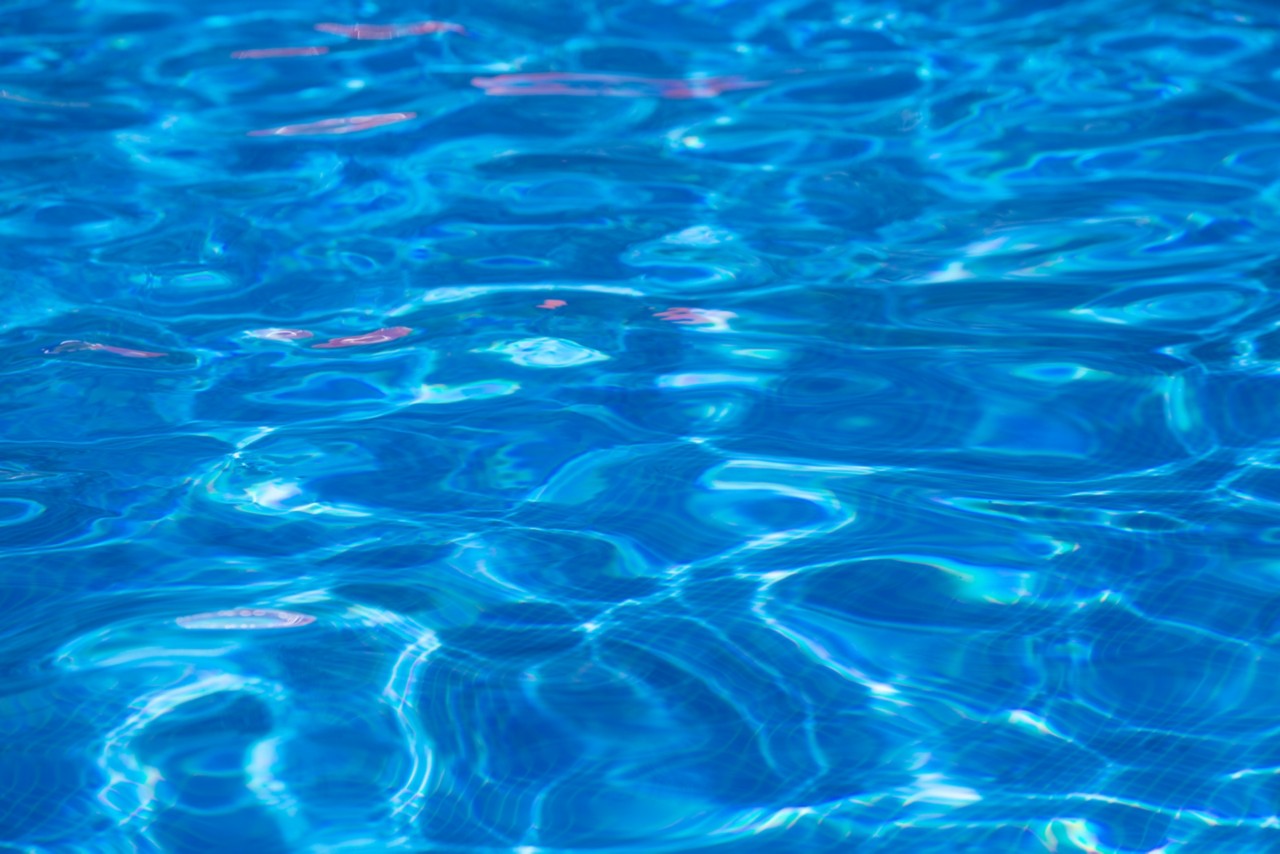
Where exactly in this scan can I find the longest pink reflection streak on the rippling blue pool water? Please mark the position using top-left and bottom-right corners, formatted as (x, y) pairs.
(471, 72), (768, 99)
